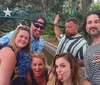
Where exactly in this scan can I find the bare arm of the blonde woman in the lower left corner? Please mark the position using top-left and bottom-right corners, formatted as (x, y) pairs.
(0, 47), (16, 85)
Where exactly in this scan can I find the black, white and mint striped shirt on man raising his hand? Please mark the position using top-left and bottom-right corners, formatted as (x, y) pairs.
(56, 34), (88, 60)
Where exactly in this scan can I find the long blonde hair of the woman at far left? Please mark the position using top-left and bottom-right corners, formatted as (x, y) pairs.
(8, 25), (31, 52)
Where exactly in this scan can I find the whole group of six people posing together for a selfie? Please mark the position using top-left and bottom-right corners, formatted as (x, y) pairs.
(0, 11), (100, 85)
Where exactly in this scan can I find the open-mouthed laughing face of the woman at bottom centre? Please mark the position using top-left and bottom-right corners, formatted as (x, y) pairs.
(31, 57), (45, 77)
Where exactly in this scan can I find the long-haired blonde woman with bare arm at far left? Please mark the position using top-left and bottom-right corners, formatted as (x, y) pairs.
(0, 26), (30, 85)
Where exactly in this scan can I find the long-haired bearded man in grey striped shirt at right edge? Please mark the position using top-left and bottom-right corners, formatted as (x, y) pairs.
(83, 11), (100, 85)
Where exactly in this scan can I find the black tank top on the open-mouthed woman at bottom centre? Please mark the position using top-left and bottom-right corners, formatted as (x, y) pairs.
(29, 68), (48, 85)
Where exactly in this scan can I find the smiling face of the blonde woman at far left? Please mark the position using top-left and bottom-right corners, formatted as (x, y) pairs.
(15, 30), (30, 49)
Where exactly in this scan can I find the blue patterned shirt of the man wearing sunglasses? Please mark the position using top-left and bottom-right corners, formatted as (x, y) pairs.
(0, 31), (44, 77)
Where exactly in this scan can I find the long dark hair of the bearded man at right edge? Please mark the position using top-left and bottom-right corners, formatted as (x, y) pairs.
(81, 10), (100, 37)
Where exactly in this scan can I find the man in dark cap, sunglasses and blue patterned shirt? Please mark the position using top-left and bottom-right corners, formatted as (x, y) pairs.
(0, 16), (46, 85)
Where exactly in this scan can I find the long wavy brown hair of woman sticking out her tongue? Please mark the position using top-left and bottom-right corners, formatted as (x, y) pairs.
(53, 53), (81, 85)
